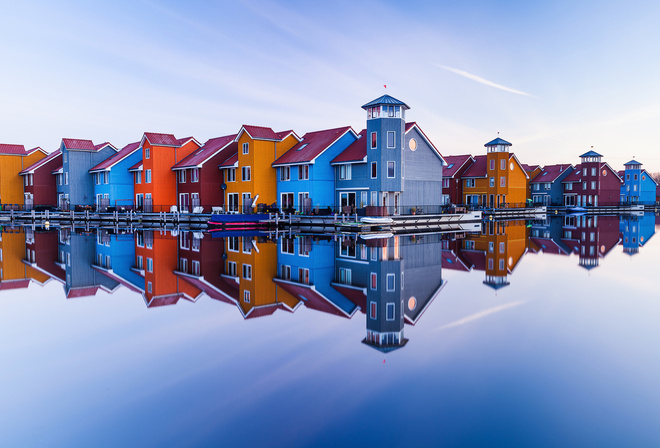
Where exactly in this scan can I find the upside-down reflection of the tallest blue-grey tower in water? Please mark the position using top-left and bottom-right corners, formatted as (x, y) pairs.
(362, 237), (408, 353)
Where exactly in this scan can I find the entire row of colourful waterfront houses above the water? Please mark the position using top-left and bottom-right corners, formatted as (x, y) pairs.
(5, 95), (658, 215)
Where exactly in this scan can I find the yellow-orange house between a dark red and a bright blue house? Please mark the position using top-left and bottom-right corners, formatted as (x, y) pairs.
(220, 125), (301, 213)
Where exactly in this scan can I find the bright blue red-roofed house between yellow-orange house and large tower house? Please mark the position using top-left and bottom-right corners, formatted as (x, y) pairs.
(272, 126), (358, 214)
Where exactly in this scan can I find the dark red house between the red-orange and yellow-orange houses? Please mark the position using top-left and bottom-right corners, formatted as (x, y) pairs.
(172, 134), (238, 213)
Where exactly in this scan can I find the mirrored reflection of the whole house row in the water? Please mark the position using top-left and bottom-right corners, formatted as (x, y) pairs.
(0, 214), (657, 352)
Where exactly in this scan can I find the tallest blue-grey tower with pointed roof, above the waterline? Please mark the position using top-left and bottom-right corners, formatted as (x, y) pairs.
(362, 95), (410, 214)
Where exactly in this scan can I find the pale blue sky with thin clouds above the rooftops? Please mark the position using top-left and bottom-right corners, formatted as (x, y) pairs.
(0, 0), (660, 172)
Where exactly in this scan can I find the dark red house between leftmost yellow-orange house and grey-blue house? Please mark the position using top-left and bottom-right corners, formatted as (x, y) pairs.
(18, 148), (62, 210)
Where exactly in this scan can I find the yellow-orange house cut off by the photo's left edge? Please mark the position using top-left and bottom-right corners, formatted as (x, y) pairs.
(0, 144), (48, 208)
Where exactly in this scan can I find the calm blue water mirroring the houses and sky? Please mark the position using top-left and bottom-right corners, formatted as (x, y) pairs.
(0, 215), (660, 447)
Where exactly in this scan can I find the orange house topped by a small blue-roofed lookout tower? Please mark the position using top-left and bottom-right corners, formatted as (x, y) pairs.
(462, 137), (529, 208)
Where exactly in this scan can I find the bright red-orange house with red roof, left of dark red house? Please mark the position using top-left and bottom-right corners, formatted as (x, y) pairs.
(129, 132), (201, 212)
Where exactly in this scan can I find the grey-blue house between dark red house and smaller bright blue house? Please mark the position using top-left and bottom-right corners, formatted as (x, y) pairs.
(55, 138), (117, 210)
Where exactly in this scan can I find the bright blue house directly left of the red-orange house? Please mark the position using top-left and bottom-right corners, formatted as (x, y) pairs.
(89, 142), (142, 211)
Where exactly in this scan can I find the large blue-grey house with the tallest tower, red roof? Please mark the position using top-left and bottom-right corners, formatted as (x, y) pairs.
(331, 95), (445, 215)
